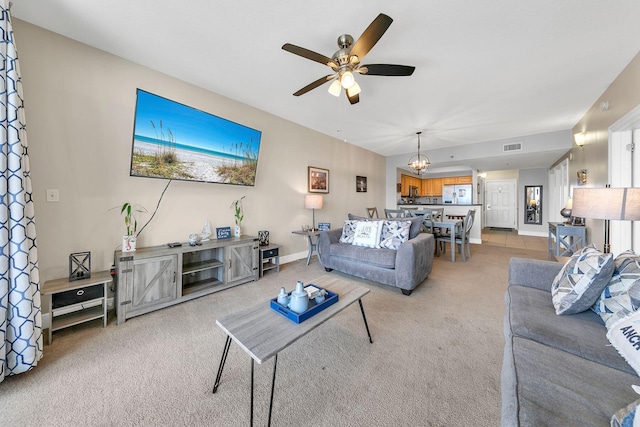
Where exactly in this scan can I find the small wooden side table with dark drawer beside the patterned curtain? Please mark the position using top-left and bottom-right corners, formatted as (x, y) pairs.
(41, 271), (111, 344)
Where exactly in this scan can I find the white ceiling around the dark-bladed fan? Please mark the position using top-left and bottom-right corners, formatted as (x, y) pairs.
(11, 0), (640, 170)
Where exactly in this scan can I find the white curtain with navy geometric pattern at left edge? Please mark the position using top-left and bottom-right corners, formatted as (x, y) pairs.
(0, 0), (42, 381)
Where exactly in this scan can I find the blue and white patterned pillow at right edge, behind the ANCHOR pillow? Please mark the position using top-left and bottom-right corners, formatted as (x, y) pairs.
(592, 250), (640, 328)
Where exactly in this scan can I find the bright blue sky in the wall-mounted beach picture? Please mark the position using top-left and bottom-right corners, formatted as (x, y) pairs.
(134, 89), (261, 154)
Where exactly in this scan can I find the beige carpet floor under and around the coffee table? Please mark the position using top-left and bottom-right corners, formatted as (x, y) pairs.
(0, 244), (546, 427)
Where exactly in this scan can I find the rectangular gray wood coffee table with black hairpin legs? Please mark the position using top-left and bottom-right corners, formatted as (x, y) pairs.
(213, 276), (373, 425)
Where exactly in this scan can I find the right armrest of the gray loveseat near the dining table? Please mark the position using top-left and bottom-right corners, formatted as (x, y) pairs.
(396, 233), (436, 290)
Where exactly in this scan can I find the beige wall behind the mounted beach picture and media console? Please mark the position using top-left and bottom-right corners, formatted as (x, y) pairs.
(14, 19), (385, 280)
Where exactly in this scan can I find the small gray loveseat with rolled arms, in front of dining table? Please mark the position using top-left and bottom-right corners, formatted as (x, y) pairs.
(318, 215), (435, 295)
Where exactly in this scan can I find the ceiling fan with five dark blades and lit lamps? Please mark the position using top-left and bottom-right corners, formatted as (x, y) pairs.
(282, 13), (416, 104)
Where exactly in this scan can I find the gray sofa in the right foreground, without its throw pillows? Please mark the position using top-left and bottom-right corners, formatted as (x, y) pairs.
(501, 258), (640, 427)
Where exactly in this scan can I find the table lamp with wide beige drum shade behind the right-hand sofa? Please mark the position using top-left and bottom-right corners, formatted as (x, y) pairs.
(571, 187), (640, 254)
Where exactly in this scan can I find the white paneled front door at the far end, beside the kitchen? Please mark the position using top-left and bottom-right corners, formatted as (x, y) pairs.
(485, 179), (517, 228)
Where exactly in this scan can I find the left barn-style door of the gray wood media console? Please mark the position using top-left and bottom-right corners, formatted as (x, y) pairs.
(128, 255), (178, 312)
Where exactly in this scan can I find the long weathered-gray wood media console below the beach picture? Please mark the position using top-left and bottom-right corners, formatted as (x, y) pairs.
(115, 236), (259, 325)
